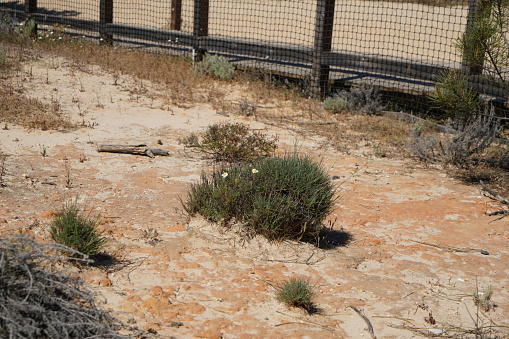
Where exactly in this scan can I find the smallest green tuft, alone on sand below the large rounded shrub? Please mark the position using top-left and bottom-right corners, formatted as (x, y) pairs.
(276, 278), (315, 312)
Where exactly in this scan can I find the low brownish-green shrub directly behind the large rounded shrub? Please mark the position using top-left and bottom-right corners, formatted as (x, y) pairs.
(199, 122), (277, 162)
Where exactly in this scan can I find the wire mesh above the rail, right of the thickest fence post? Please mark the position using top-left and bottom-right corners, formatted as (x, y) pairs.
(333, 0), (468, 67)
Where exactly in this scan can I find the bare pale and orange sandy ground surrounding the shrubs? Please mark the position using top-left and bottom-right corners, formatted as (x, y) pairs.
(0, 54), (509, 338)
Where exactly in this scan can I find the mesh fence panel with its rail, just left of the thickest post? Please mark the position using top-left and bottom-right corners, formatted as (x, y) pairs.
(203, 0), (316, 77)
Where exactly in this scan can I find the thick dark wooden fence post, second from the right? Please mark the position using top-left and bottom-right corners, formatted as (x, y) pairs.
(311, 0), (335, 98)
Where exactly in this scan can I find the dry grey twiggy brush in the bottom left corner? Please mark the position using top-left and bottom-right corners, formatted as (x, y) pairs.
(0, 236), (135, 339)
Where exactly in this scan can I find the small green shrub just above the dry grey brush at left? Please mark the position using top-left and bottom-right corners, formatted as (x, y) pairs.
(50, 199), (108, 255)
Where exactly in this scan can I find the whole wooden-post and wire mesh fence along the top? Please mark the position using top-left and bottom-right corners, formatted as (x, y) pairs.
(0, 0), (508, 114)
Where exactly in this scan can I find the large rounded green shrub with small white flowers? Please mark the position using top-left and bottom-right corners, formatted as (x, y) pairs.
(184, 153), (335, 240)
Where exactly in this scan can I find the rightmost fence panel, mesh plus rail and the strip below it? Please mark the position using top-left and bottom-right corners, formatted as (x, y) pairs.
(331, 0), (469, 109)
